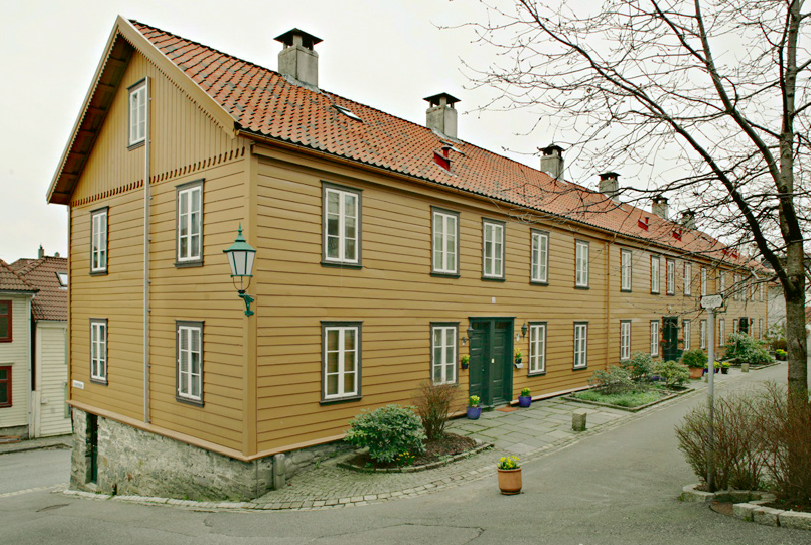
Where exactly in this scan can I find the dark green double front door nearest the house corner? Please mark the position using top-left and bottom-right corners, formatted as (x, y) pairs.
(470, 318), (513, 407)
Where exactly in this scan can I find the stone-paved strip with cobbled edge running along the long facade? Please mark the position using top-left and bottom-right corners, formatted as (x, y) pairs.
(65, 369), (756, 510)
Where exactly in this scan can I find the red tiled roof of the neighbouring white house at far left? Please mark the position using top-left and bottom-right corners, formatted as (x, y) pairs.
(10, 256), (68, 321)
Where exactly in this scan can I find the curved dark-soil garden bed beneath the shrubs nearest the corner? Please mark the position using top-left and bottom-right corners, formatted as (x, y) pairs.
(338, 433), (493, 473)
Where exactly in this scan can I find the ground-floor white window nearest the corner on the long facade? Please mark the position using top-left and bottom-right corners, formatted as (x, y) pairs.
(321, 322), (361, 401)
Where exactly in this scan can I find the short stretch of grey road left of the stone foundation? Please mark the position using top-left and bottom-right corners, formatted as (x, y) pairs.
(0, 449), (70, 496)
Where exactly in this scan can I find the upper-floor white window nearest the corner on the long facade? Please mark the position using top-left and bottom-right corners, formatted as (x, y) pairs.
(322, 182), (361, 265)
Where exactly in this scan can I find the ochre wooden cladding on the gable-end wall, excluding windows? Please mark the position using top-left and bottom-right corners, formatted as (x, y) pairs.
(70, 49), (247, 448)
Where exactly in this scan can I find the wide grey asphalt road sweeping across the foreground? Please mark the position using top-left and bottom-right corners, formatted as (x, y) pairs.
(0, 365), (811, 545)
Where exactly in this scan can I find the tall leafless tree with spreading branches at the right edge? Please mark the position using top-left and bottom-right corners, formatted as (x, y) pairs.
(469, 0), (811, 394)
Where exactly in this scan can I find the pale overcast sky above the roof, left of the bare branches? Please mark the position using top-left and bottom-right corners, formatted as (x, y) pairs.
(0, 0), (616, 261)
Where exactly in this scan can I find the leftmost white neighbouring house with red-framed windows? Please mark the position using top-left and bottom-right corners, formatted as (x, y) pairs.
(0, 259), (37, 437)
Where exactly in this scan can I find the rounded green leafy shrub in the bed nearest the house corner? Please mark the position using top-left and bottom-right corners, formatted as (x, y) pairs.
(346, 405), (425, 463)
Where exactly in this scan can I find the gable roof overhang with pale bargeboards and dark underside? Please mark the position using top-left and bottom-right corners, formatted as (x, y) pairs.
(47, 16), (235, 204)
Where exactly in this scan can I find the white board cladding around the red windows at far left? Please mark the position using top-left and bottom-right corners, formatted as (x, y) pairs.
(0, 292), (31, 428)
